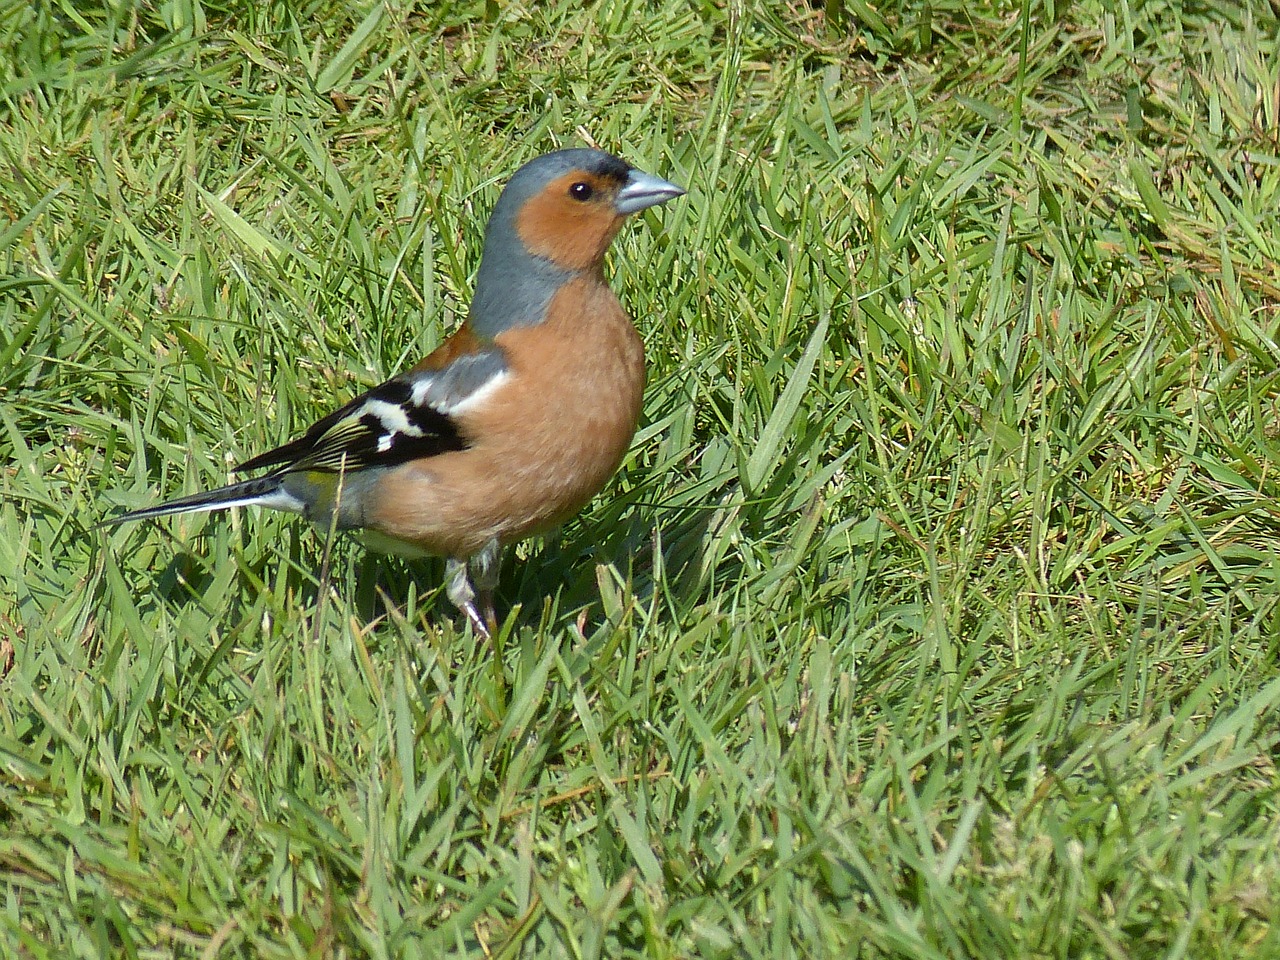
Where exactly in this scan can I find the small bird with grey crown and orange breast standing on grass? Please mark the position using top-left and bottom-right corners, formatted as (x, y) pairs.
(106, 150), (685, 637)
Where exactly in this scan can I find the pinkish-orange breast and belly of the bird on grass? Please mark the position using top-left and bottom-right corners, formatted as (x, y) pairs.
(365, 279), (644, 558)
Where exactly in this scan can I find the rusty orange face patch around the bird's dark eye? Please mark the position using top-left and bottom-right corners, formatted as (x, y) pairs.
(516, 170), (623, 270)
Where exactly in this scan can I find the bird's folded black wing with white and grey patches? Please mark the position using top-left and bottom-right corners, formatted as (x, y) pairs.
(236, 343), (508, 472)
